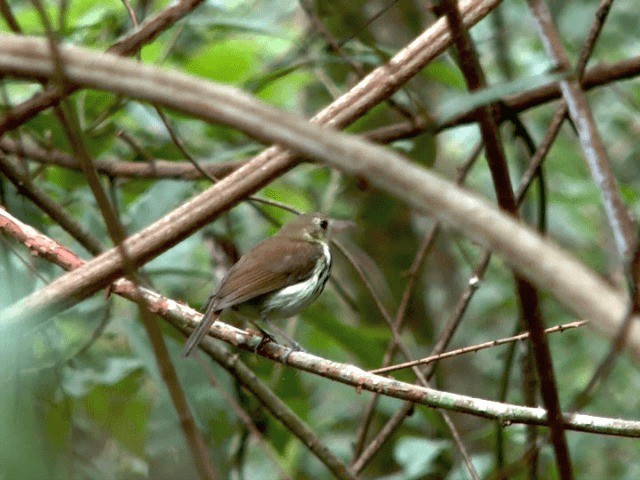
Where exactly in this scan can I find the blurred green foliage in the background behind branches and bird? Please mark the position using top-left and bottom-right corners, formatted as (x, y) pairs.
(0, 0), (640, 480)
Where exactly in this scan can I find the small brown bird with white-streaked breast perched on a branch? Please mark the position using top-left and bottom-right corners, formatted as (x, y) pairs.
(182, 213), (331, 357)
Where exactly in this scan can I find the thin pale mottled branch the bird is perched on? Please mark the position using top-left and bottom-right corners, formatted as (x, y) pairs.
(5, 208), (640, 438)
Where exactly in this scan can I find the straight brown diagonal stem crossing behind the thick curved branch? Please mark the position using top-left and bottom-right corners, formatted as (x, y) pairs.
(0, 0), (500, 312)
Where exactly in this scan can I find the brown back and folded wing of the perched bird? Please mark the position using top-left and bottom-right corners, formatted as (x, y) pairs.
(213, 237), (323, 310)
